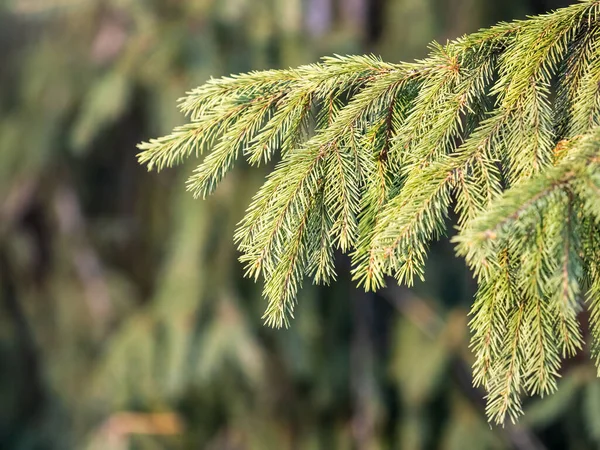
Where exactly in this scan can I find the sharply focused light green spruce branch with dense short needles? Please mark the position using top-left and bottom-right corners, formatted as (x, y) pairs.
(139, 0), (600, 423)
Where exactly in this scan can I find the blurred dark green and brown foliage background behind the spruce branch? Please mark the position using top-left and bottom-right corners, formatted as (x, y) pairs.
(0, 0), (600, 450)
